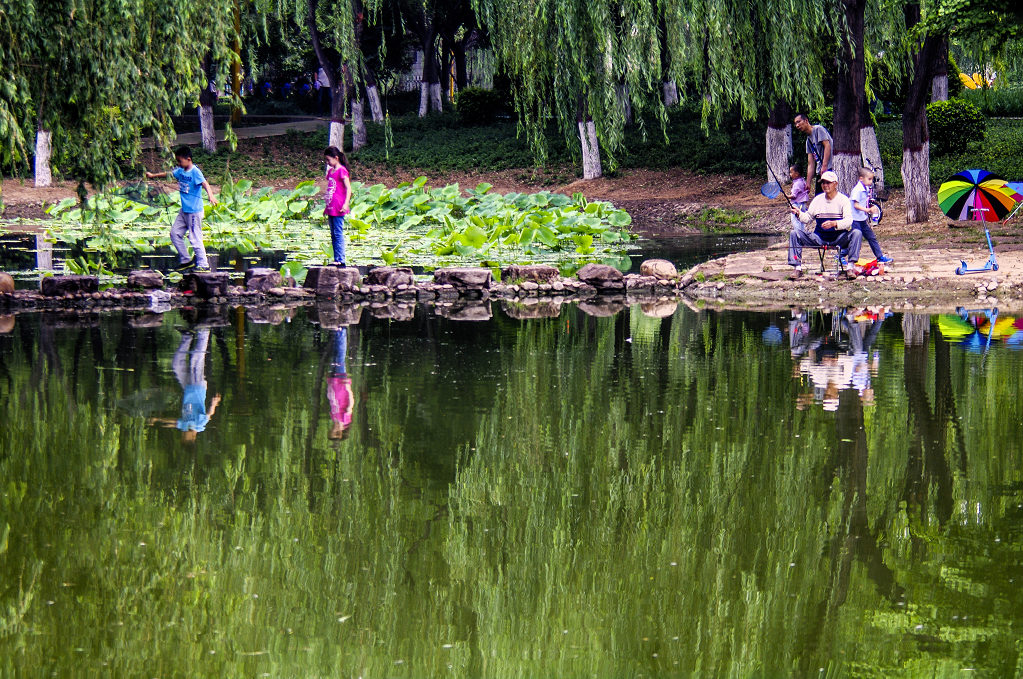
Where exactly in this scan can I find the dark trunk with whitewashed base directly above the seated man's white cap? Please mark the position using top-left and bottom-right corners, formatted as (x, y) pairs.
(821, 0), (866, 193)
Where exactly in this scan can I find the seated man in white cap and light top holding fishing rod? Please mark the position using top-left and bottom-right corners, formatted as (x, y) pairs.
(789, 171), (863, 280)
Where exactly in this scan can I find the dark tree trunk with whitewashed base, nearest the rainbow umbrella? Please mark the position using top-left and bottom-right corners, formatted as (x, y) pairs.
(902, 5), (942, 224)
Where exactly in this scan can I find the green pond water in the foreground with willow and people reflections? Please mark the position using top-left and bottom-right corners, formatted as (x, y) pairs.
(0, 307), (1023, 678)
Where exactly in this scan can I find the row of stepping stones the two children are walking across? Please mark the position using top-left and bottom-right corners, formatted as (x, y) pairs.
(0, 260), (693, 320)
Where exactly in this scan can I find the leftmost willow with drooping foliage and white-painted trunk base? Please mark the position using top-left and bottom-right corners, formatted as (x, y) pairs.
(0, 0), (232, 186)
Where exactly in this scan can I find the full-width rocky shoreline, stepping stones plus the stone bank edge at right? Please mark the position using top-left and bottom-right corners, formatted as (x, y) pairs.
(0, 255), (1023, 320)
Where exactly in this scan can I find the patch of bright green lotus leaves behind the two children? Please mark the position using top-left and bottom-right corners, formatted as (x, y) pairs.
(48, 177), (633, 266)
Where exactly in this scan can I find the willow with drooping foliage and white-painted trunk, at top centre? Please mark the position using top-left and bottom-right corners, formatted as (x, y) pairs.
(476, 0), (664, 179)
